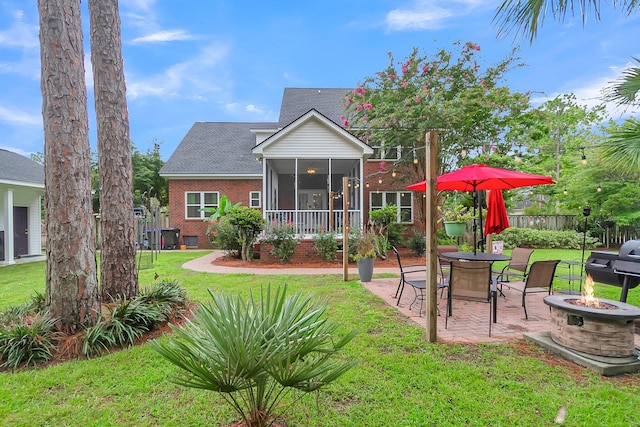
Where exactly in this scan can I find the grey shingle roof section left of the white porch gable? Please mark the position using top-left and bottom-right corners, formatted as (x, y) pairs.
(160, 122), (278, 175)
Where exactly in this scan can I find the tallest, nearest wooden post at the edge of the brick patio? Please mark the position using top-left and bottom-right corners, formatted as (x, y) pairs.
(424, 131), (438, 342)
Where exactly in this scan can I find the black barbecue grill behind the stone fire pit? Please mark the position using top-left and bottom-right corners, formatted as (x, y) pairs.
(584, 240), (640, 302)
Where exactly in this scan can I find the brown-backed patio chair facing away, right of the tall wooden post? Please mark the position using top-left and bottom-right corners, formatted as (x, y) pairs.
(444, 260), (497, 336)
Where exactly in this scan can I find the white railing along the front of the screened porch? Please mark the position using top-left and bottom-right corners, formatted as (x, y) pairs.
(265, 210), (361, 237)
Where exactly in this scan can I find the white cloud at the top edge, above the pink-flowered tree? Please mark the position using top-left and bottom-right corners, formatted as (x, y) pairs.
(385, 0), (495, 31)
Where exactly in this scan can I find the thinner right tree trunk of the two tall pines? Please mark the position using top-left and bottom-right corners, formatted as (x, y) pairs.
(89, 0), (138, 301)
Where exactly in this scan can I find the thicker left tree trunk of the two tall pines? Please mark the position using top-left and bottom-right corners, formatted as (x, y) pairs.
(38, 0), (100, 334)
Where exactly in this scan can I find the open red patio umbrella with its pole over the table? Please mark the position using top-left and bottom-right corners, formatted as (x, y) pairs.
(405, 164), (554, 252)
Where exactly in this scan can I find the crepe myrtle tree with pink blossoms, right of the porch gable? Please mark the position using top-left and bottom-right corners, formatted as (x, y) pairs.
(343, 41), (529, 180)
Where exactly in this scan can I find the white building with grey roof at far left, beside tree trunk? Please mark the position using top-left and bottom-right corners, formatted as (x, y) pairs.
(0, 149), (44, 265)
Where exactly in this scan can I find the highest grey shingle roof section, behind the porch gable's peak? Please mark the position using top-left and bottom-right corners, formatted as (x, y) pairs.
(278, 88), (353, 127)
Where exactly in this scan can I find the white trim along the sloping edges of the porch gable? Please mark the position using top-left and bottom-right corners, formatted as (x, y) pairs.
(252, 109), (373, 159)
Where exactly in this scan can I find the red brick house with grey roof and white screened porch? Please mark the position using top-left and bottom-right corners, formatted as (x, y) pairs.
(160, 88), (416, 248)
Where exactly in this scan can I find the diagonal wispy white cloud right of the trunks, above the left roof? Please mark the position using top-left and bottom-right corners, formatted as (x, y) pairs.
(127, 44), (229, 99)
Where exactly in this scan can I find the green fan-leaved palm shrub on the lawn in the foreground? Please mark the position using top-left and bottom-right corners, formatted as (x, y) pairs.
(150, 285), (355, 427)
